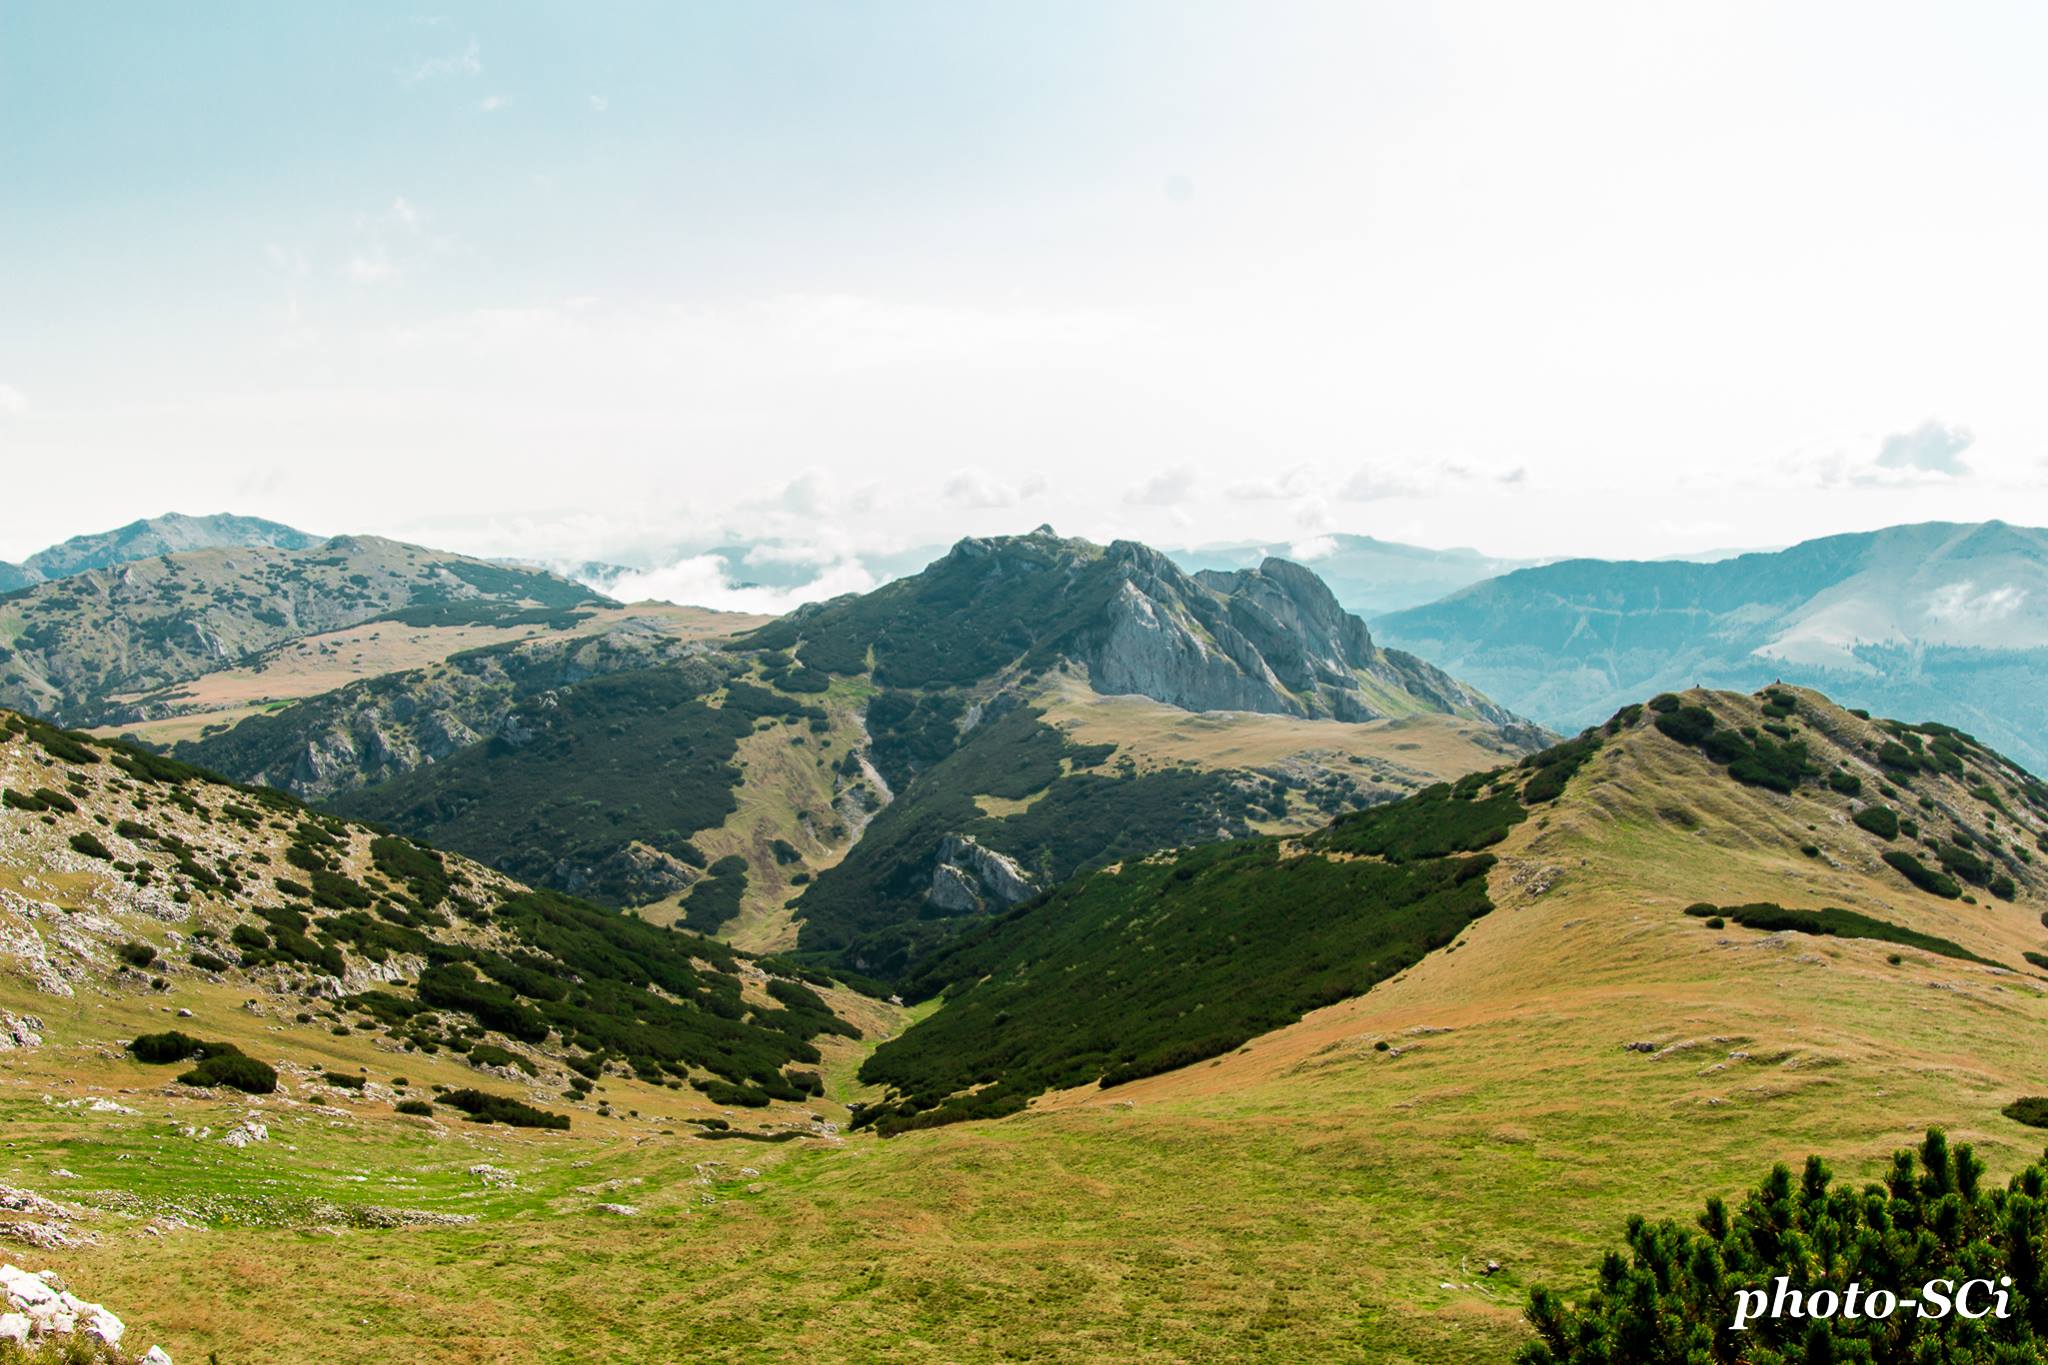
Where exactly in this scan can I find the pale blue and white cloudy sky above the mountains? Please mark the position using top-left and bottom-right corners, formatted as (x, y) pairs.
(0, 0), (2048, 602)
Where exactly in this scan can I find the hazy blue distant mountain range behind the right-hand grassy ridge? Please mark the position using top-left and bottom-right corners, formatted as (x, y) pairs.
(1372, 522), (2048, 772)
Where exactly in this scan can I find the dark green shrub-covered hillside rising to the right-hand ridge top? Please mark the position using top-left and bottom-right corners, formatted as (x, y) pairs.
(860, 688), (2048, 1134)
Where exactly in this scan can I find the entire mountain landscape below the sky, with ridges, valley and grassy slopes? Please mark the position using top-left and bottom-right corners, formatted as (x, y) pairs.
(16, 518), (2048, 1365)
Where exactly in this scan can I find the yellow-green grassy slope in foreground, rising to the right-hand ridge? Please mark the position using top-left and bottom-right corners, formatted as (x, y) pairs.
(12, 700), (2048, 1363)
